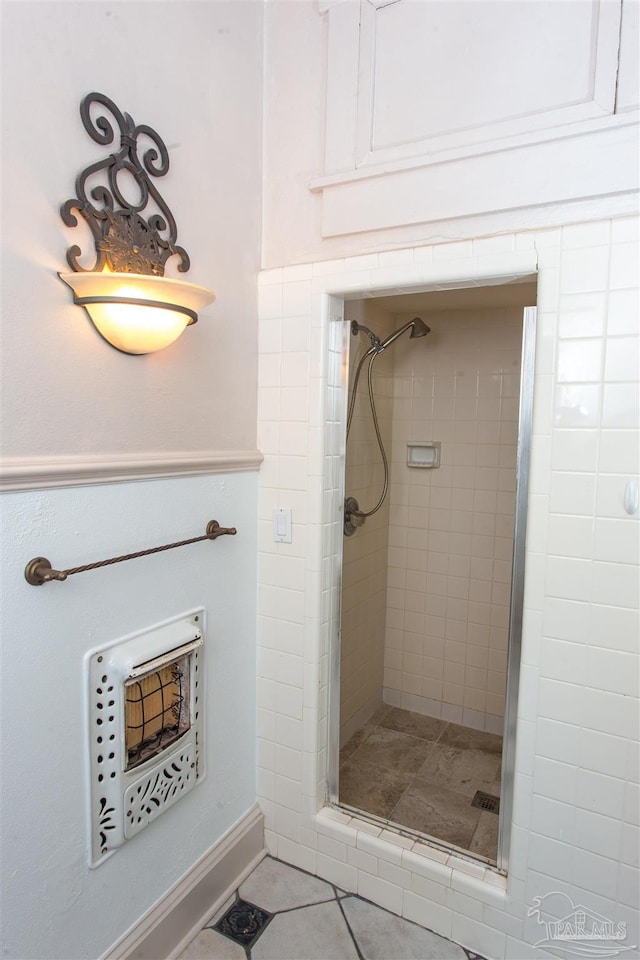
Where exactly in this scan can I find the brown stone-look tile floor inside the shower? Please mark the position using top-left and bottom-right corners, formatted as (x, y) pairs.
(339, 705), (502, 862)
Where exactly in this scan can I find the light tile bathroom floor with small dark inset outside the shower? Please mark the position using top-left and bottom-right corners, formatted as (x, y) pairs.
(178, 857), (483, 960)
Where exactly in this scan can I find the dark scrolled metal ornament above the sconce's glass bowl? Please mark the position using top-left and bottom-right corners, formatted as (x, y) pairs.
(60, 93), (190, 276)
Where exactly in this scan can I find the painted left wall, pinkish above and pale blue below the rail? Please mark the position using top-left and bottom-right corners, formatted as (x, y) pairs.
(2, 2), (262, 960)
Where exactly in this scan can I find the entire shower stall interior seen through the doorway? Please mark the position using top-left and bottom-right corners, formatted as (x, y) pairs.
(329, 277), (536, 871)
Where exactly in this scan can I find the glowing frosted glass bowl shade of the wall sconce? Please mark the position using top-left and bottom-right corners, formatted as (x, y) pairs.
(59, 271), (215, 354)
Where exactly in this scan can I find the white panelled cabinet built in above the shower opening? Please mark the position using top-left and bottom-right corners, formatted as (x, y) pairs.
(311, 0), (638, 237)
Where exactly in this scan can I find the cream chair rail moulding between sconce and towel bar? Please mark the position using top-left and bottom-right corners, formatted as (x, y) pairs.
(0, 450), (263, 493)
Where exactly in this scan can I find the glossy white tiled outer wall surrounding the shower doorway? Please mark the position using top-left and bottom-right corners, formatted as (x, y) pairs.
(257, 217), (640, 960)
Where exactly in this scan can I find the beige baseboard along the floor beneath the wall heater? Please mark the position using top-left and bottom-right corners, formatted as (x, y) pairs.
(102, 804), (267, 960)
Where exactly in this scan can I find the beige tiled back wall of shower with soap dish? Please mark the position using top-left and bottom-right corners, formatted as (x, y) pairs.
(384, 307), (523, 734)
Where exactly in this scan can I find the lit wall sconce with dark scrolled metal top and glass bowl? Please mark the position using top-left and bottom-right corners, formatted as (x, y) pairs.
(58, 93), (215, 354)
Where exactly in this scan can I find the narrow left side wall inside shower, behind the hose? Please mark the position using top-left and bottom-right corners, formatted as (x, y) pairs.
(340, 300), (393, 744)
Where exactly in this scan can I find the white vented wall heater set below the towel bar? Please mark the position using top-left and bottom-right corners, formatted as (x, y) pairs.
(87, 608), (205, 866)
